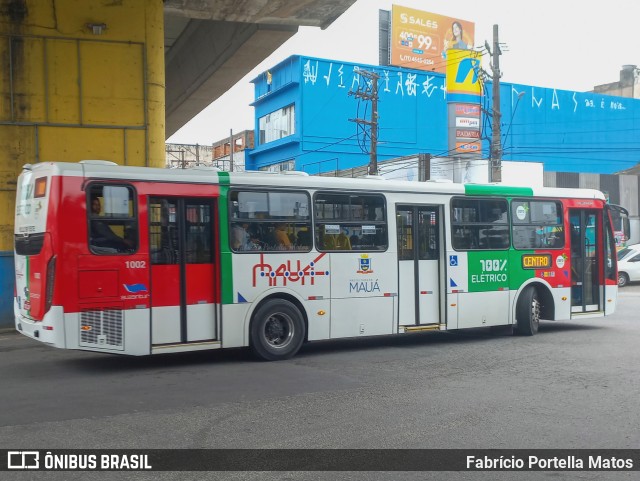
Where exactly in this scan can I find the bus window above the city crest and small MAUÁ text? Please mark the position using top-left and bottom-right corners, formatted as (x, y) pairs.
(315, 192), (388, 251)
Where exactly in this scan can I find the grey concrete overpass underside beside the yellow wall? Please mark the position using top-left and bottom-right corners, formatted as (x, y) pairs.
(164, 0), (355, 138)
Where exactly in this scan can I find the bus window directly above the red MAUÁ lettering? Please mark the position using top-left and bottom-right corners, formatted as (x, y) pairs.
(229, 190), (312, 252)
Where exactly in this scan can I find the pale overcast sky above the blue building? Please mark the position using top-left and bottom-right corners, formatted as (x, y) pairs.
(168, 0), (640, 145)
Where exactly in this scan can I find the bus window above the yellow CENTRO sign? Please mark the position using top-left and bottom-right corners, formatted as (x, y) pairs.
(511, 200), (564, 249)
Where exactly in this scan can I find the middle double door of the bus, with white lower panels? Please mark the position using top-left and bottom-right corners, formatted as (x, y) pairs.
(396, 205), (442, 326)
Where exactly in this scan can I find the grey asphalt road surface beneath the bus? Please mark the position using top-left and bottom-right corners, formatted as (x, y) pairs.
(0, 285), (640, 480)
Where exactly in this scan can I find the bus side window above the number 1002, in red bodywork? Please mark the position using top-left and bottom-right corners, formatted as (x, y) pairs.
(87, 184), (138, 255)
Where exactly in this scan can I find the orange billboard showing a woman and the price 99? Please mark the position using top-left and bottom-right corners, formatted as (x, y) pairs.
(390, 5), (475, 73)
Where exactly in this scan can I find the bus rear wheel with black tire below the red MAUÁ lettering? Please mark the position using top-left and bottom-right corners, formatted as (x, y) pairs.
(250, 299), (305, 361)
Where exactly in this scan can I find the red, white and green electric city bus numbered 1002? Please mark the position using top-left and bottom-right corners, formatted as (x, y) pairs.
(14, 161), (618, 360)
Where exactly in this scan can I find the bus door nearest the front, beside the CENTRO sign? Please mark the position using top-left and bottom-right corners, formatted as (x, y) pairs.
(569, 209), (601, 313)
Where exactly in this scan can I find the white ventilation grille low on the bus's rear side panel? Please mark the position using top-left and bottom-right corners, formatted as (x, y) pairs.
(80, 308), (124, 350)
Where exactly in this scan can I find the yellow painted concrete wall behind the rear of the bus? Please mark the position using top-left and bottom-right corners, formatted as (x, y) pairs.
(0, 0), (165, 251)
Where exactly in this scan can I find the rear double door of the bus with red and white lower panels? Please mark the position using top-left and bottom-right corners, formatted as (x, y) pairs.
(149, 197), (219, 346)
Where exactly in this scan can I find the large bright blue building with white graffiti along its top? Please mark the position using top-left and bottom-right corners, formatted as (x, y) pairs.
(247, 55), (640, 174)
